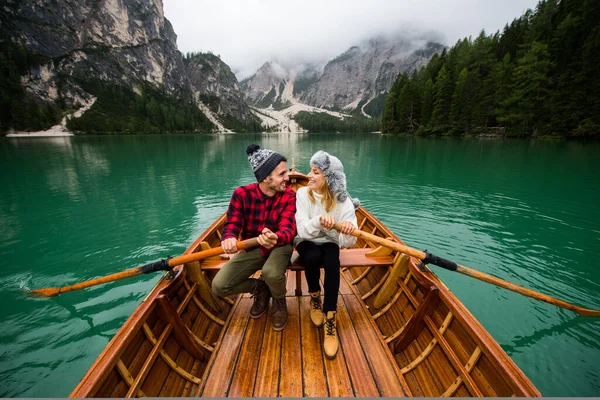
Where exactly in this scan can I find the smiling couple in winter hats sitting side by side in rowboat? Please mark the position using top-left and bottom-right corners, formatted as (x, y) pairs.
(212, 144), (358, 358)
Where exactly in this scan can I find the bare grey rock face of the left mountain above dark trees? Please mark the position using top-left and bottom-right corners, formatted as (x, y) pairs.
(0, 0), (249, 133)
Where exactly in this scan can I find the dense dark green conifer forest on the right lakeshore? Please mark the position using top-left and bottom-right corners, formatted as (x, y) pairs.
(381, 0), (600, 138)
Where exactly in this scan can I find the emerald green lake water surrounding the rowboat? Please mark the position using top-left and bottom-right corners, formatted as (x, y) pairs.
(0, 134), (600, 397)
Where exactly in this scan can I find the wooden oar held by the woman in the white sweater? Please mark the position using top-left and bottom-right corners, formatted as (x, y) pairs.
(333, 222), (600, 317)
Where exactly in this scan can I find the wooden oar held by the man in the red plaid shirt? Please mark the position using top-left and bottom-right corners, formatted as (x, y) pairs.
(27, 238), (258, 297)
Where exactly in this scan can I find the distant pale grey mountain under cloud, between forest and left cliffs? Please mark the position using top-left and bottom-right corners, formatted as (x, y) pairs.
(241, 37), (445, 116)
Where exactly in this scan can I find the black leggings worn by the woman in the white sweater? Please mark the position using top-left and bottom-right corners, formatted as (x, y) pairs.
(296, 240), (340, 314)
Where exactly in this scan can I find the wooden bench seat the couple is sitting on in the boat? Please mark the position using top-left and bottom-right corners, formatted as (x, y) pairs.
(200, 248), (394, 296)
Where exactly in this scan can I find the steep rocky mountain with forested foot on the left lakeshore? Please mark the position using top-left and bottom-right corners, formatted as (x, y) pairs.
(0, 0), (257, 132)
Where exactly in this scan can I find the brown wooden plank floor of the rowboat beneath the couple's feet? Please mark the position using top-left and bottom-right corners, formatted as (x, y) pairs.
(198, 271), (407, 397)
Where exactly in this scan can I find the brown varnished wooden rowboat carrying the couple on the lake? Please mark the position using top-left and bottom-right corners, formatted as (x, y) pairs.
(70, 170), (541, 397)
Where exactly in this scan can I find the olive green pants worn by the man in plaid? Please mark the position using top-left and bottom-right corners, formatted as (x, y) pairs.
(212, 244), (292, 299)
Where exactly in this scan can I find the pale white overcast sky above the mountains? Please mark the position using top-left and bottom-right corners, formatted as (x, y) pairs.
(163, 0), (538, 80)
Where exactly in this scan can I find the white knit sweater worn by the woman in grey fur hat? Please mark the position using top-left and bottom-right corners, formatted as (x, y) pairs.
(294, 187), (358, 247)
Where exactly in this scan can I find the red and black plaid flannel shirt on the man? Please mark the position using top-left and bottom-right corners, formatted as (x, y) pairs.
(223, 183), (296, 256)
